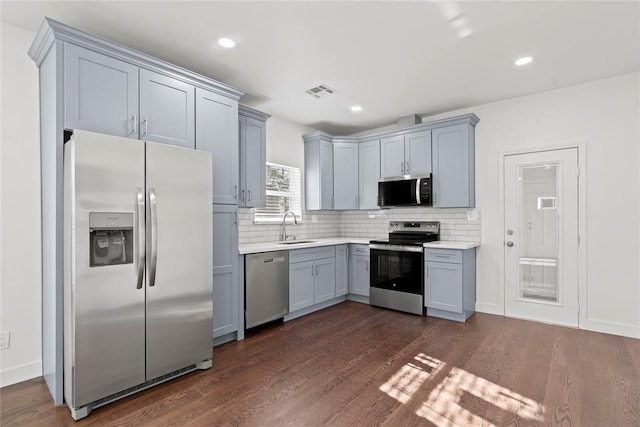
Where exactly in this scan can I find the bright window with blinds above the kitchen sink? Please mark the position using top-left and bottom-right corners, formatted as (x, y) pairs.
(255, 162), (302, 223)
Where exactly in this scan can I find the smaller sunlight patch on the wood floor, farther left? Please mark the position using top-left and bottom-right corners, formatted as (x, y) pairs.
(380, 353), (444, 403)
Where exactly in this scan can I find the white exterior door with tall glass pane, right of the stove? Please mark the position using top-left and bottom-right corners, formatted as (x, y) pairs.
(504, 148), (579, 326)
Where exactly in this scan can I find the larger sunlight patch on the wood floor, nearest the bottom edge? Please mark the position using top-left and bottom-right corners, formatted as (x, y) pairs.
(416, 367), (545, 426)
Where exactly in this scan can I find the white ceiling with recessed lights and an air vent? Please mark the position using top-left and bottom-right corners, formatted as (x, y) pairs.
(0, 0), (640, 134)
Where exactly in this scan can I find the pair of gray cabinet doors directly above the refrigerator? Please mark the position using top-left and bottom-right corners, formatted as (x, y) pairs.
(64, 43), (195, 148)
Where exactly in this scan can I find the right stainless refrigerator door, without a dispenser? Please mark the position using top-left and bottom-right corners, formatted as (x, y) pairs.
(146, 142), (213, 380)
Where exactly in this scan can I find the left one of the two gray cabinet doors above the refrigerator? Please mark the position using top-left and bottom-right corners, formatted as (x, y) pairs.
(64, 43), (138, 139)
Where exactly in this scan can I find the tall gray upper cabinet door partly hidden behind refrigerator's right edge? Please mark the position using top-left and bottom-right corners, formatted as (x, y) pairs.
(196, 88), (239, 205)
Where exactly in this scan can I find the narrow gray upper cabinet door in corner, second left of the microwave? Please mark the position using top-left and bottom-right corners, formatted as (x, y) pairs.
(333, 142), (358, 210)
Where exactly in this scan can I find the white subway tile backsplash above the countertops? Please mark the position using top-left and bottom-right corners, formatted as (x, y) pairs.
(238, 208), (480, 245)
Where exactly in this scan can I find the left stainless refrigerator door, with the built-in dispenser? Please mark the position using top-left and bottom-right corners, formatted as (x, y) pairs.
(64, 131), (145, 408)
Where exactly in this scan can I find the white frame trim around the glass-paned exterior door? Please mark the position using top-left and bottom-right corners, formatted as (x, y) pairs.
(498, 141), (588, 329)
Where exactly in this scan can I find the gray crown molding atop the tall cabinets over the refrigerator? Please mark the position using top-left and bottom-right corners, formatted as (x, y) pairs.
(28, 17), (244, 101)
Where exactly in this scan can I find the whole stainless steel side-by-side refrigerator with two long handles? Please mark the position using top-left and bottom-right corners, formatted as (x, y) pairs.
(64, 130), (213, 419)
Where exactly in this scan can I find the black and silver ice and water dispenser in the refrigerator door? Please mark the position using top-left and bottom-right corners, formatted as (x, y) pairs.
(89, 212), (133, 267)
